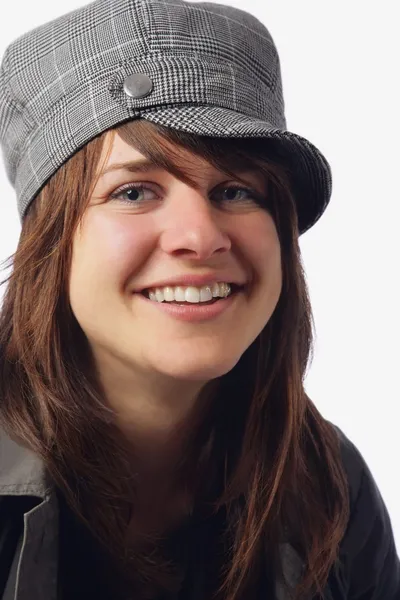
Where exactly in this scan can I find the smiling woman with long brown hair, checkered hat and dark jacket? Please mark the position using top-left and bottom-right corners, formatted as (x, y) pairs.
(0, 0), (400, 600)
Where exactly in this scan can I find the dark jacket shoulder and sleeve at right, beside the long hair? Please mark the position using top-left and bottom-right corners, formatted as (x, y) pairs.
(334, 425), (400, 600)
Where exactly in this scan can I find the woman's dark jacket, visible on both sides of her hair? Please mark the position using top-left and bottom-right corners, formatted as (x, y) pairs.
(0, 426), (400, 600)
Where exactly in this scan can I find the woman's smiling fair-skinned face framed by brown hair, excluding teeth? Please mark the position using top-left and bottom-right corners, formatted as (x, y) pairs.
(69, 135), (282, 382)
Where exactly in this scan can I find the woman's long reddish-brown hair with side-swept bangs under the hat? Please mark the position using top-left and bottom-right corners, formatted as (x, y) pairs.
(0, 120), (349, 600)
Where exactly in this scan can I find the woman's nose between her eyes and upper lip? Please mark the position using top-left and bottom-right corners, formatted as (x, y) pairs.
(160, 184), (231, 261)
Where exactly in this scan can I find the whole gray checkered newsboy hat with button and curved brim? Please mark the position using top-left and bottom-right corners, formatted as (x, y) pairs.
(0, 0), (331, 233)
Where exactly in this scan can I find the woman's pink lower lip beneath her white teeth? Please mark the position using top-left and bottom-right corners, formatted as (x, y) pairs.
(136, 291), (242, 322)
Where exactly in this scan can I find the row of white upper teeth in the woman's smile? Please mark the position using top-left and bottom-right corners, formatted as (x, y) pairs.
(148, 282), (231, 304)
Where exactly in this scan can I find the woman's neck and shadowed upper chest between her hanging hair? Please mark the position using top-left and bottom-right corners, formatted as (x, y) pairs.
(92, 354), (219, 539)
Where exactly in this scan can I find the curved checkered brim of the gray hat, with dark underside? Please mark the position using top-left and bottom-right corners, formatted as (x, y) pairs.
(141, 106), (332, 235)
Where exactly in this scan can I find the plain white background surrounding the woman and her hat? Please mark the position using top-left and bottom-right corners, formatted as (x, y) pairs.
(0, 0), (400, 550)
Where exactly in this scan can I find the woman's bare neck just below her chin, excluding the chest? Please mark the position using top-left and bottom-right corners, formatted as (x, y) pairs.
(94, 352), (219, 476)
